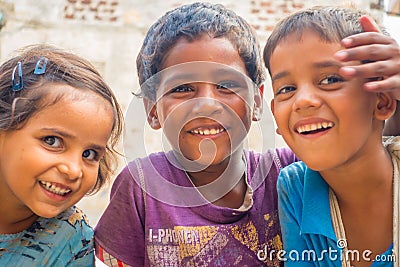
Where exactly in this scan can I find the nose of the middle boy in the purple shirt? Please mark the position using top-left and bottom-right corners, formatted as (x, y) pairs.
(193, 83), (223, 116)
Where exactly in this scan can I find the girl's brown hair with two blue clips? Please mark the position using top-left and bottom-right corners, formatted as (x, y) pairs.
(0, 44), (123, 193)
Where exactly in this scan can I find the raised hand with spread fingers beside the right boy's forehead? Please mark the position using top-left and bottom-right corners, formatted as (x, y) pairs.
(335, 16), (400, 100)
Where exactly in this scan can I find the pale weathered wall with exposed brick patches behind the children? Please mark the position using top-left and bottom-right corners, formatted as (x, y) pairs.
(0, 0), (400, 225)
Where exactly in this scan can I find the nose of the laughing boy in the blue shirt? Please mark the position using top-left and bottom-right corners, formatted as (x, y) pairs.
(293, 85), (321, 112)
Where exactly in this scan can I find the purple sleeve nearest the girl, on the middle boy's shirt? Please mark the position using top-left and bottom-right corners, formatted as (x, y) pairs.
(95, 166), (145, 266)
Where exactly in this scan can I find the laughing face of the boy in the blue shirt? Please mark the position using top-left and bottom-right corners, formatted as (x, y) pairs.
(270, 31), (384, 171)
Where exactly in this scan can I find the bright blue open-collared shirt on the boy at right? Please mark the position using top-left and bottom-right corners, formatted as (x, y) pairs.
(277, 162), (394, 267)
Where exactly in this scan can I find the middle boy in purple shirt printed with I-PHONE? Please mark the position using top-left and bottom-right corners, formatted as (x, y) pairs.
(95, 3), (400, 266)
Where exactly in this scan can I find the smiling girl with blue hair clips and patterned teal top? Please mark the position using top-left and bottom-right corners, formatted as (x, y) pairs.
(0, 45), (122, 266)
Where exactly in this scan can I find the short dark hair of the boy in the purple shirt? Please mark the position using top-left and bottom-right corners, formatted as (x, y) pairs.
(136, 3), (265, 100)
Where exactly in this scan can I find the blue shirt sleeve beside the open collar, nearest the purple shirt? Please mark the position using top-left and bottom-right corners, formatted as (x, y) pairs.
(277, 168), (314, 267)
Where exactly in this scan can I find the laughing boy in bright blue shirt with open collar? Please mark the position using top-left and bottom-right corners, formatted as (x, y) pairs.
(264, 4), (400, 267)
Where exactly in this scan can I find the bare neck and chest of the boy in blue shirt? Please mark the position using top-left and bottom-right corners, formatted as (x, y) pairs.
(321, 143), (393, 266)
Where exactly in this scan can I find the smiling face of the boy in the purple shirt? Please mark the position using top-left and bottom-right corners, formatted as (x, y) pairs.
(147, 36), (261, 170)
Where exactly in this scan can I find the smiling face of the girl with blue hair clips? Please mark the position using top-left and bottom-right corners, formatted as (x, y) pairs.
(0, 84), (114, 222)
